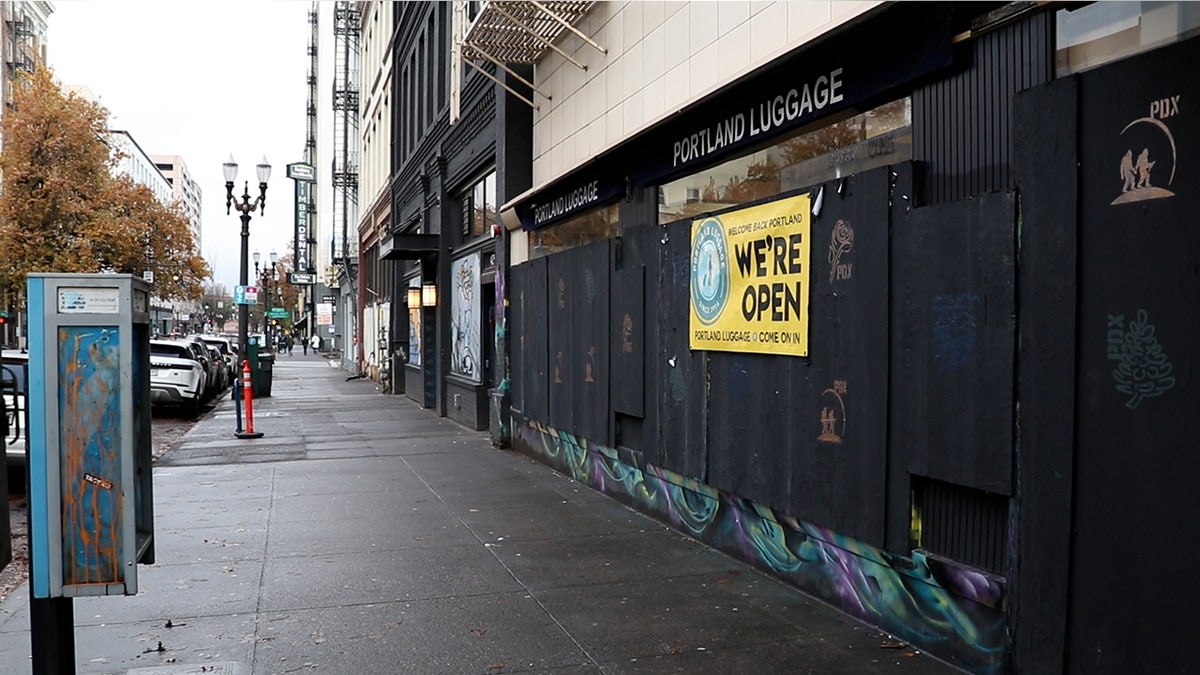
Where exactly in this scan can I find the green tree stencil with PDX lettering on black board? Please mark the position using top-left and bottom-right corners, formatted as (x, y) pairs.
(1108, 310), (1175, 410)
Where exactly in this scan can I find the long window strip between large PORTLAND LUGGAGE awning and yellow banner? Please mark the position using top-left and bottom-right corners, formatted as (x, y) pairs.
(659, 98), (912, 222)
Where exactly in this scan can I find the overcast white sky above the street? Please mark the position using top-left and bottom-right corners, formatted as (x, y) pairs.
(47, 0), (311, 293)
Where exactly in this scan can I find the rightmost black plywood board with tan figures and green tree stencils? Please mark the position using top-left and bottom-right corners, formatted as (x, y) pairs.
(1064, 40), (1200, 673)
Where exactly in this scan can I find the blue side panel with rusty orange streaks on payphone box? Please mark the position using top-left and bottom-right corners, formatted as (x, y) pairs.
(58, 327), (125, 585)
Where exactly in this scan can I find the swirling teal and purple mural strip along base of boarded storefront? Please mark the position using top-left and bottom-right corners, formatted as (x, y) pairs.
(514, 422), (1009, 673)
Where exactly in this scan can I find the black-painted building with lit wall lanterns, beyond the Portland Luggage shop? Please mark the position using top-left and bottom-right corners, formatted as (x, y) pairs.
(380, 2), (532, 432)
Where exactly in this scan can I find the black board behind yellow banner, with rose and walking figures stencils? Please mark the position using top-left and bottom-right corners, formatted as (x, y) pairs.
(708, 168), (907, 545)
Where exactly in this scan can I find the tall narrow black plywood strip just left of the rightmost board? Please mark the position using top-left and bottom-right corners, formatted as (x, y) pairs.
(1012, 69), (1078, 673)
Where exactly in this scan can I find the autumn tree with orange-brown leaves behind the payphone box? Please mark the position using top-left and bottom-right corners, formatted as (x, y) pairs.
(0, 68), (210, 306)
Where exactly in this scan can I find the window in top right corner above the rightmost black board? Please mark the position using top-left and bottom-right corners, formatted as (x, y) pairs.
(1055, 2), (1200, 77)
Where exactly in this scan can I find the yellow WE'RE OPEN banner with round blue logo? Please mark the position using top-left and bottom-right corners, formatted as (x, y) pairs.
(688, 195), (811, 357)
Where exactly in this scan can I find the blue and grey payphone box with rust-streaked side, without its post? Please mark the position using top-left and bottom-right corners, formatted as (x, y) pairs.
(26, 274), (154, 598)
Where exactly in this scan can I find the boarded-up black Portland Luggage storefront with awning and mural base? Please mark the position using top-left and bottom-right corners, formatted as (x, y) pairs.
(494, 4), (1200, 673)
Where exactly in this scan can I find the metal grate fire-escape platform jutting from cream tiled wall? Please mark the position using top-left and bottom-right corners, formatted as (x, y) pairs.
(462, 0), (607, 108)
